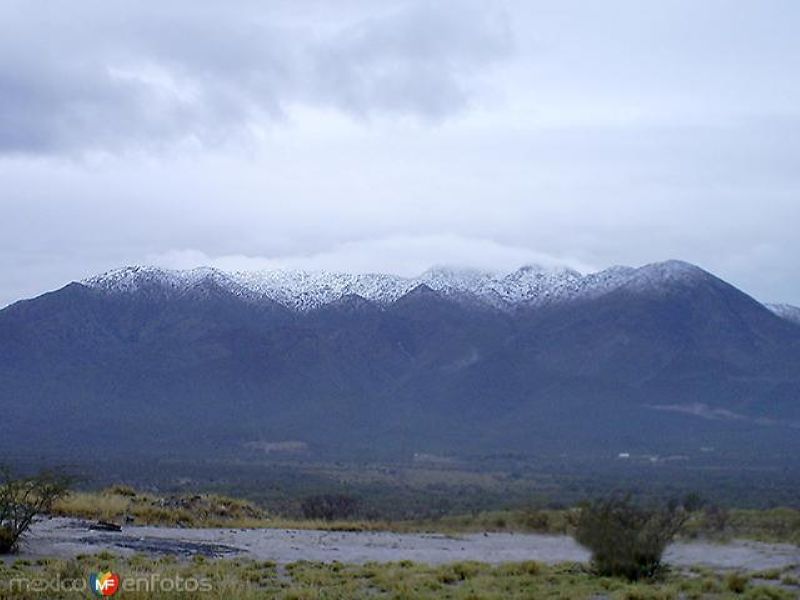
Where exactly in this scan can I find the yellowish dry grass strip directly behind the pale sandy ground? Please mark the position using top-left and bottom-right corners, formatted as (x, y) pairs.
(51, 485), (800, 545)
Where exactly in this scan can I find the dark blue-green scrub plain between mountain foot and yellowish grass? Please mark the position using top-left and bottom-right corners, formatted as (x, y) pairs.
(47, 452), (800, 521)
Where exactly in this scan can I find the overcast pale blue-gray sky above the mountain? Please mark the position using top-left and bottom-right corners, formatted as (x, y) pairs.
(0, 0), (800, 306)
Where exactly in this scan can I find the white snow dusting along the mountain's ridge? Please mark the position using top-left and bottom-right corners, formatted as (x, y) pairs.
(82, 261), (705, 311)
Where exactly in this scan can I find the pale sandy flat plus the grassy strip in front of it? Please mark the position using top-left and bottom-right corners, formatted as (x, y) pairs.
(0, 517), (800, 600)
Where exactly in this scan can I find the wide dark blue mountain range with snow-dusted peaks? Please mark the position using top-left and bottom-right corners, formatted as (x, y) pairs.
(0, 261), (800, 461)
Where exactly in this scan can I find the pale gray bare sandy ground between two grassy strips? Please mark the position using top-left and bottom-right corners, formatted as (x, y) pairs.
(10, 518), (800, 571)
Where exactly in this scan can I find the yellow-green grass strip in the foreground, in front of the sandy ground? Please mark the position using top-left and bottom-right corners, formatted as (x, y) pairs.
(0, 553), (798, 600)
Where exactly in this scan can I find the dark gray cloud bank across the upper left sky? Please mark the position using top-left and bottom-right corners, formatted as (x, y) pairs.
(0, 1), (511, 153)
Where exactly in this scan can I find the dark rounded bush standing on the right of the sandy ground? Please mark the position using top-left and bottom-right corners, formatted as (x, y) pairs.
(575, 495), (687, 580)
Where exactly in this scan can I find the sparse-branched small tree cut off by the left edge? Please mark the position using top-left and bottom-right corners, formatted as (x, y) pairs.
(0, 468), (72, 554)
